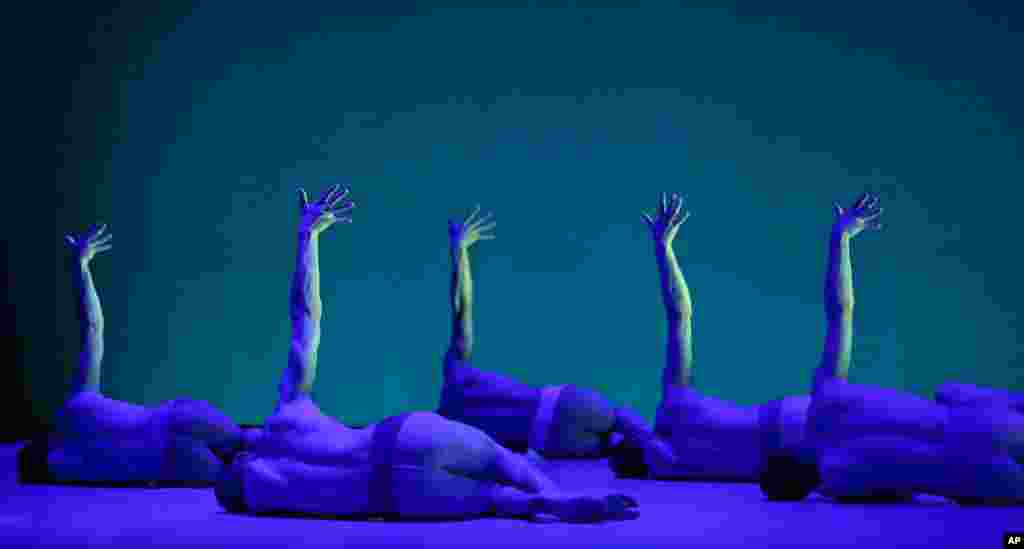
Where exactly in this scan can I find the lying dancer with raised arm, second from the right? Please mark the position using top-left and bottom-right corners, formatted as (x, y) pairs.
(612, 194), (810, 481)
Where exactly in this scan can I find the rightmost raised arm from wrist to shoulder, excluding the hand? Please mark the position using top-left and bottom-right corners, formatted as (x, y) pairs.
(814, 230), (854, 387)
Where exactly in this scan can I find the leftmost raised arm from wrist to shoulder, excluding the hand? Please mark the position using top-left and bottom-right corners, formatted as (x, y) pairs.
(72, 261), (103, 391)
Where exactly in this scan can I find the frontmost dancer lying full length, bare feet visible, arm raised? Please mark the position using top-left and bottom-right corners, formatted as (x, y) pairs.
(215, 185), (637, 521)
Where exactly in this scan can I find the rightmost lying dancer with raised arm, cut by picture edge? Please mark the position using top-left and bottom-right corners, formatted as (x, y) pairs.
(762, 196), (1024, 503)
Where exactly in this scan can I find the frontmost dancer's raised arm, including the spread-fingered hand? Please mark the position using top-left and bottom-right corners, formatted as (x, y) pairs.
(279, 185), (355, 404)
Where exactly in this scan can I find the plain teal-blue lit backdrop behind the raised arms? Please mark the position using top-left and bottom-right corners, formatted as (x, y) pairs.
(18, 2), (1024, 430)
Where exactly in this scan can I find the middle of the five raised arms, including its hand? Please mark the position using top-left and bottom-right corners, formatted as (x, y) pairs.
(444, 206), (496, 376)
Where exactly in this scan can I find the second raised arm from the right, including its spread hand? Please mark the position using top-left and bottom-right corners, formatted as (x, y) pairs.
(643, 193), (693, 394)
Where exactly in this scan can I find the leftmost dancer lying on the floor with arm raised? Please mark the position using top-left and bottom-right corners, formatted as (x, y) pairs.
(18, 225), (243, 484)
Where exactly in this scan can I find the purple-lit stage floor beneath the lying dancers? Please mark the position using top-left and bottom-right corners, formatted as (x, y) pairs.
(0, 446), (1024, 549)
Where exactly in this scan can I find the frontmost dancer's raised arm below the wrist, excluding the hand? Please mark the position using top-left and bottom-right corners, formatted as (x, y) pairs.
(281, 231), (322, 402)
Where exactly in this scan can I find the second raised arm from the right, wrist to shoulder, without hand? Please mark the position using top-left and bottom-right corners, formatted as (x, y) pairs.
(655, 243), (693, 387)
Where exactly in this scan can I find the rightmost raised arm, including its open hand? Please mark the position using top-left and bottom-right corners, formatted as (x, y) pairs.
(813, 193), (882, 391)
